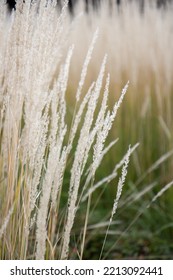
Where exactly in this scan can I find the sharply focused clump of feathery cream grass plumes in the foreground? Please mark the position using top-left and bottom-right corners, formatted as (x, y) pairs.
(0, 0), (137, 259)
